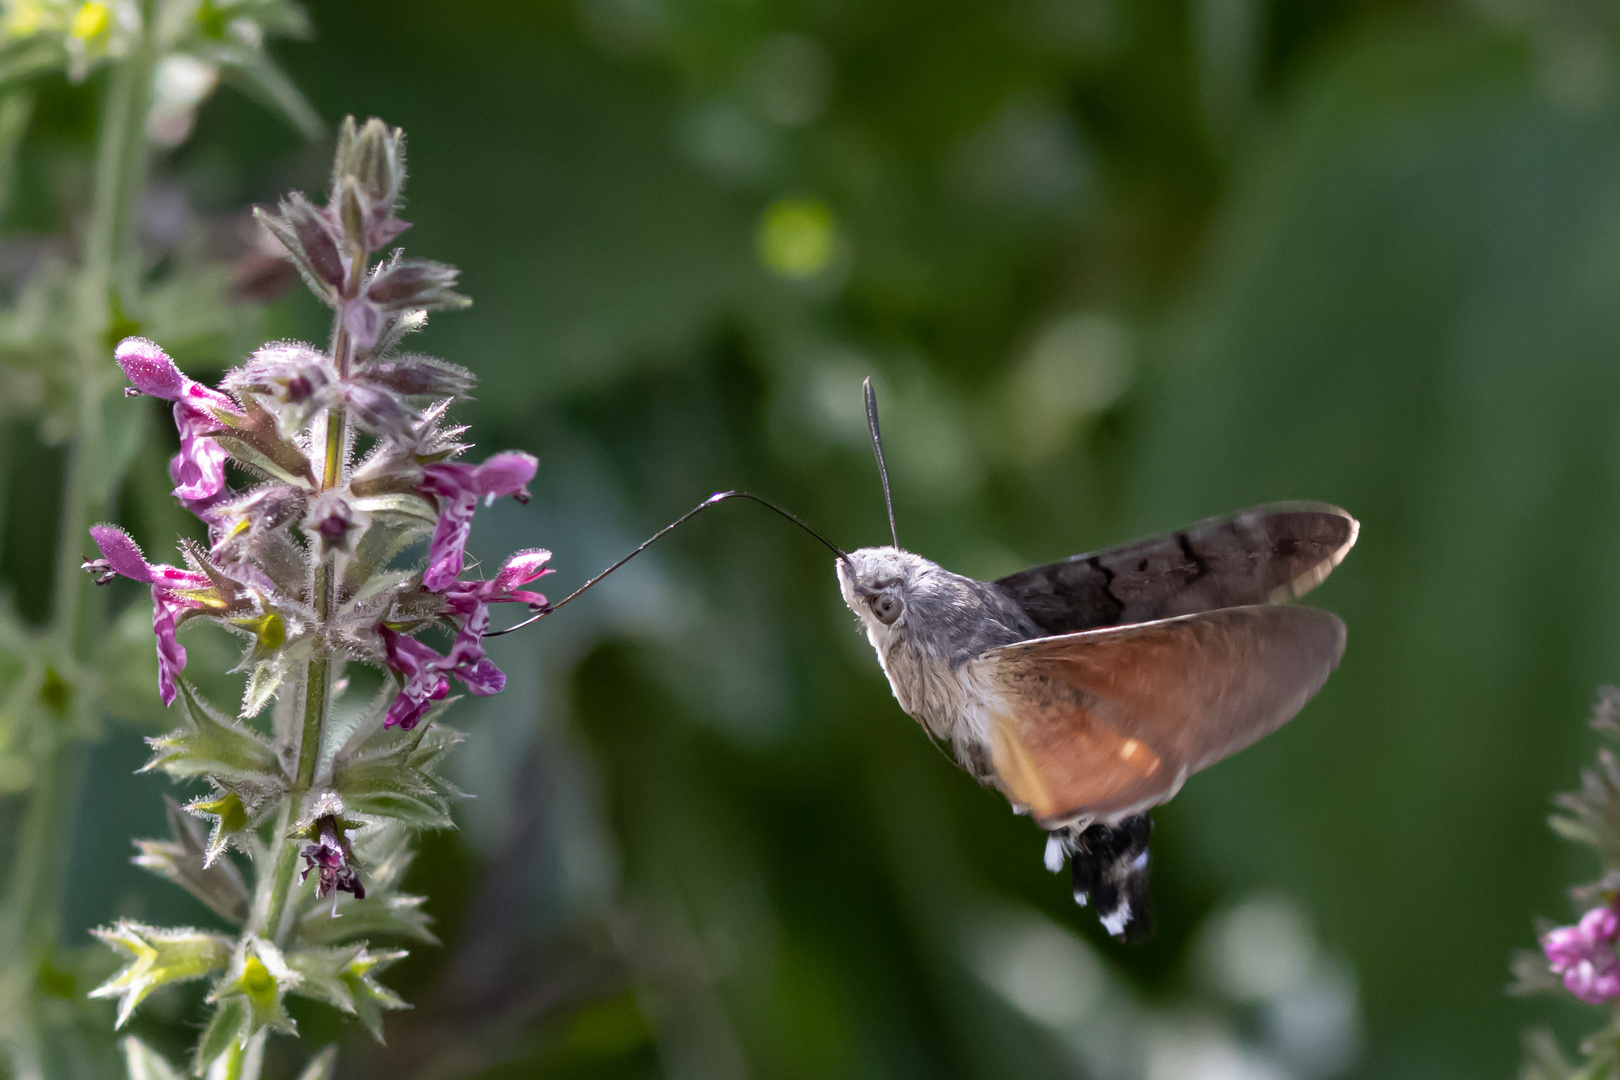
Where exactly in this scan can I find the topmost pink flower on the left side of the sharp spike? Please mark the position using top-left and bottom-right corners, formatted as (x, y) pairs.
(113, 337), (240, 517)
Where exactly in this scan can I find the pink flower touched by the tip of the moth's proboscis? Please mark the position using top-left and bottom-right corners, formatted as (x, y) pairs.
(377, 547), (551, 732)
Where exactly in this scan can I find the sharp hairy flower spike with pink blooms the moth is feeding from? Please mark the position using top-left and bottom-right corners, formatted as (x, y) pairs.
(84, 118), (531, 1080)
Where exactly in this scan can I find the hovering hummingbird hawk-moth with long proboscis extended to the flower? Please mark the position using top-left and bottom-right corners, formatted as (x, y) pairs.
(502, 379), (1361, 939)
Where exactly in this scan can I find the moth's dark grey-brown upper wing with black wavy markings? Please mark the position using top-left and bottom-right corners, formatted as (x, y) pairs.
(996, 502), (1361, 635)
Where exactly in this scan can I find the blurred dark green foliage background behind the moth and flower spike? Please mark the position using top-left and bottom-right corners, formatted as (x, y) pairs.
(15, 0), (1620, 1080)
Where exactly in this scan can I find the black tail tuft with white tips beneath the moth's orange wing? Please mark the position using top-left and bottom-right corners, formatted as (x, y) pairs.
(1047, 814), (1153, 941)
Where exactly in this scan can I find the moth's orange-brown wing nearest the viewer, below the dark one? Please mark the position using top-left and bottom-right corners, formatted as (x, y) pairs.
(974, 606), (1345, 827)
